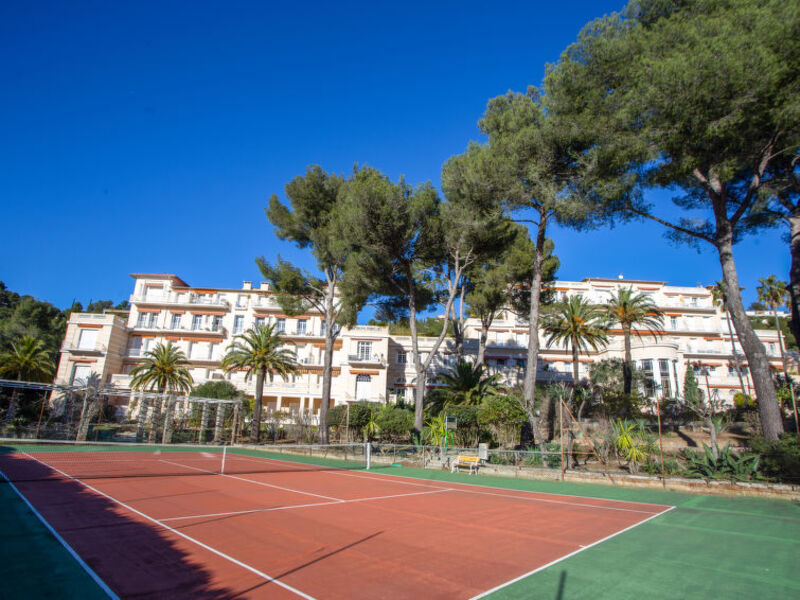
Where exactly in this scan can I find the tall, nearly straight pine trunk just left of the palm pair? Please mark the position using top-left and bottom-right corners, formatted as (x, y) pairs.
(523, 212), (550, 452)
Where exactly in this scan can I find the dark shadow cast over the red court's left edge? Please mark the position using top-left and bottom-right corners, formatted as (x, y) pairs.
(0, 453), (244, 599)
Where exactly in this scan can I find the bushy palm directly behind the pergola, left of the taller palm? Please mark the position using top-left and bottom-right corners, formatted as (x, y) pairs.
(130, 342), (194, 443)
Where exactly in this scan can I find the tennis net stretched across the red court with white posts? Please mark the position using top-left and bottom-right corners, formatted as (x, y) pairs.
(0, 440), (369, 481)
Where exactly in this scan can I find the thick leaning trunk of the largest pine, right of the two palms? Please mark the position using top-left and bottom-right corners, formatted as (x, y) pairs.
(717, 236), (783, 440)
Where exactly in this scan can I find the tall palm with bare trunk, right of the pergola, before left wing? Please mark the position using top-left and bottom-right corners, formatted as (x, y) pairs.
(222, 324), (297, 443)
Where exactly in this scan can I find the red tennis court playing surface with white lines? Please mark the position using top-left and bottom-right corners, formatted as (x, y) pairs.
(0, 452), (670, 600)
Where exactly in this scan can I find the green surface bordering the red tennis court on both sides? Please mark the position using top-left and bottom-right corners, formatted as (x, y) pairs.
(0, 454), (800, 600)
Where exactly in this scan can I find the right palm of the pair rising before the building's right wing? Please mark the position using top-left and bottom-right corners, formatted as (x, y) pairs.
(605, 287), (664, 395)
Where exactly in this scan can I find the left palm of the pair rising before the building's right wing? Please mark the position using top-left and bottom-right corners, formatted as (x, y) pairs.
(544, 295), (608, 394)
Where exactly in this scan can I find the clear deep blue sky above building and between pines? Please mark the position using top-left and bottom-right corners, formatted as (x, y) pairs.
(0, 1), (789, 318)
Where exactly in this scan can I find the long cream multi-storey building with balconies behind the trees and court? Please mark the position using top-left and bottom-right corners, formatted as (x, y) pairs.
(56, 273), (781, 416)
